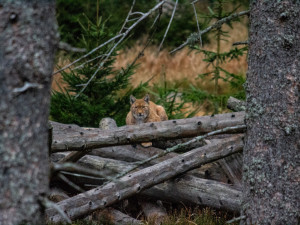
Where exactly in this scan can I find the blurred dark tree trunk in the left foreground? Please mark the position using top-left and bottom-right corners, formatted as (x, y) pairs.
(0, 0), (58, 225)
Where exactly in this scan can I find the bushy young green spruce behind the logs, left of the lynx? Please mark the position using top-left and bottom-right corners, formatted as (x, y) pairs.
(50, 14), (147, 127)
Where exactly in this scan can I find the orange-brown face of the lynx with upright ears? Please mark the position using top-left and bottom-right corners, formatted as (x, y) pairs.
(130, 96), (150, 123)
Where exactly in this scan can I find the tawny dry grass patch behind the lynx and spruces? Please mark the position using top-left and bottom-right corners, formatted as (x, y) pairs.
(115, 20), (248, 90)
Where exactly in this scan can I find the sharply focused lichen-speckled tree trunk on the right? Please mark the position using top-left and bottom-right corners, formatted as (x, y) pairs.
(241, 0), (300, 224)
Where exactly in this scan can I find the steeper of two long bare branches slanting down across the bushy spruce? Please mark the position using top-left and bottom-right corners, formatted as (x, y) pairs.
(75, 1), (164, 98)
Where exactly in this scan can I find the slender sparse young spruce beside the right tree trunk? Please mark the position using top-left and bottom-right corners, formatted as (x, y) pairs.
(184, 0), (248, 113)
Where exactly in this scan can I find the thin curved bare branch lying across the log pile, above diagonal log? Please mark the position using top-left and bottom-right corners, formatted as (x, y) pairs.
(114, 125), (246, 179)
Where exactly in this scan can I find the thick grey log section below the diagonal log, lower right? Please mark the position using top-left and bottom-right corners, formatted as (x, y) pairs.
(141, 175), (242, 212)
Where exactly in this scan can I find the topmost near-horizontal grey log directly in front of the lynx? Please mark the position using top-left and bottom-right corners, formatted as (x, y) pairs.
(51, 112), (245, 152)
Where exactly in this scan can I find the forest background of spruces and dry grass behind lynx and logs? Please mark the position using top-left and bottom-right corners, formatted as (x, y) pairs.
(50, 0), (249, 127)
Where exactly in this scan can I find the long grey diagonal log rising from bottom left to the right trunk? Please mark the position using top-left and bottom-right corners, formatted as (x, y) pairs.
(47, 136), (243, 222)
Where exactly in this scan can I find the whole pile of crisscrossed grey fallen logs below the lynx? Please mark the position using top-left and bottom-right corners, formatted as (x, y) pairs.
(46, 96), (245, 224)
